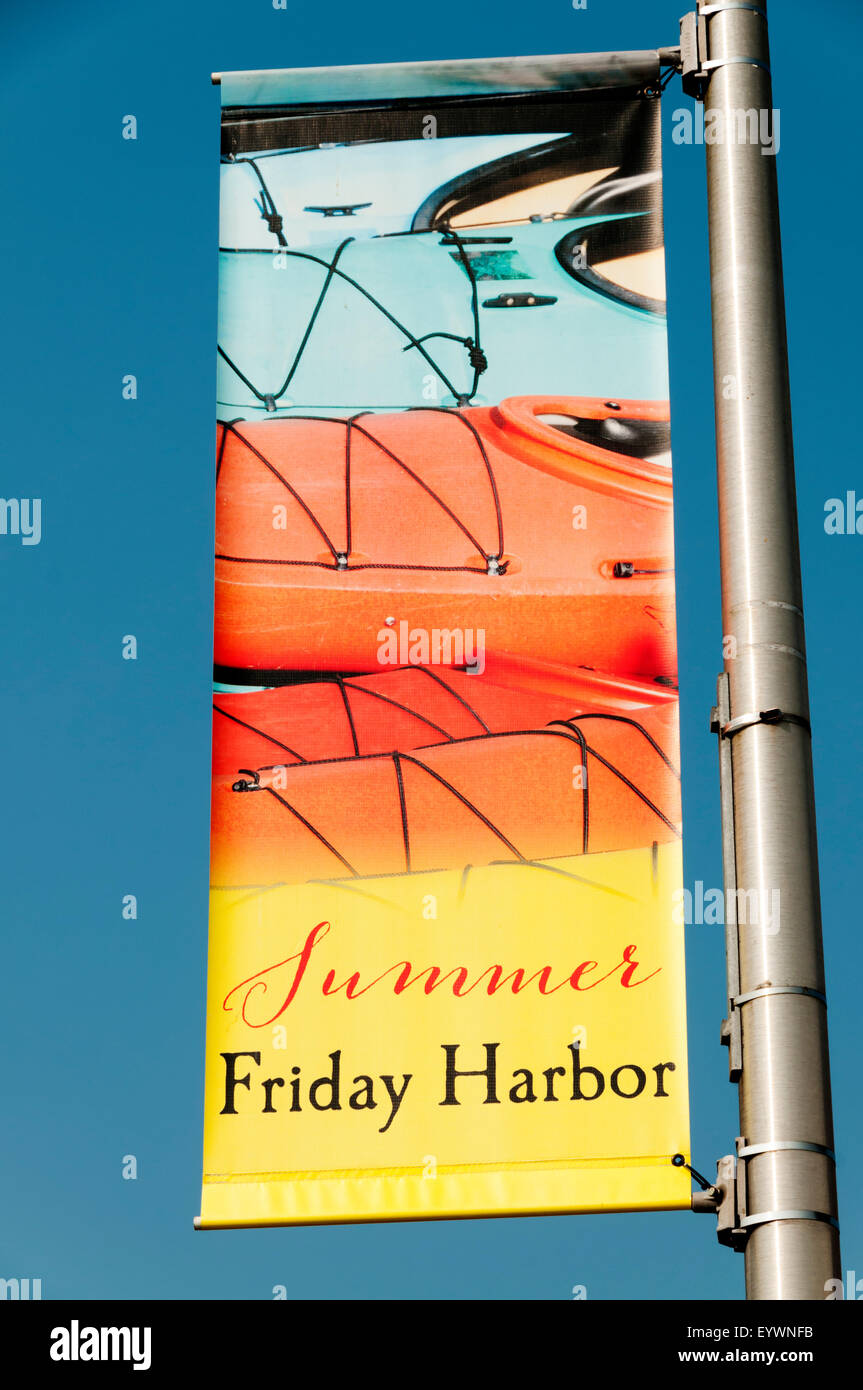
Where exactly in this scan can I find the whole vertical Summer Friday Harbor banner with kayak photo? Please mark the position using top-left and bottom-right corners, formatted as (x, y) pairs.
(197, 53), (689, 1227)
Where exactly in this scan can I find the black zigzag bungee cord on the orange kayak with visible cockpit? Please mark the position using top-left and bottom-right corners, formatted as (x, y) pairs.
(215, 406), (509, 575)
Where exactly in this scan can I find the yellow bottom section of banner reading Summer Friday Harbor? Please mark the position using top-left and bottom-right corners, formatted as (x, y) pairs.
(196, 844), (691, 1227)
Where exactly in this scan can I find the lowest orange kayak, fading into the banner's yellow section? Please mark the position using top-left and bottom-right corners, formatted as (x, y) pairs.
(211, 700), (680, 887)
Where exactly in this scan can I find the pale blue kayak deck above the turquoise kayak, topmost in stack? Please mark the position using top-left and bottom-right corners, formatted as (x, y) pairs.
(220, 132), (571, 250)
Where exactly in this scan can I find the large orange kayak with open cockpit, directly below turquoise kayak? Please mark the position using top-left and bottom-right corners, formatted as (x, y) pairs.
(215, 396), (675, 681)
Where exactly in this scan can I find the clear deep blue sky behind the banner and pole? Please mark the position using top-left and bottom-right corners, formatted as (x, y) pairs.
(0, 0), (863, 1300)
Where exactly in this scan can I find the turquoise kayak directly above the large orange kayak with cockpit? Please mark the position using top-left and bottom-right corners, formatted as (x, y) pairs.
(218, 214), (668, 420)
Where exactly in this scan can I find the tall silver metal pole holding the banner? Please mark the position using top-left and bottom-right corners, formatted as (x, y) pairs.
(699, 0), (841, 1300)
